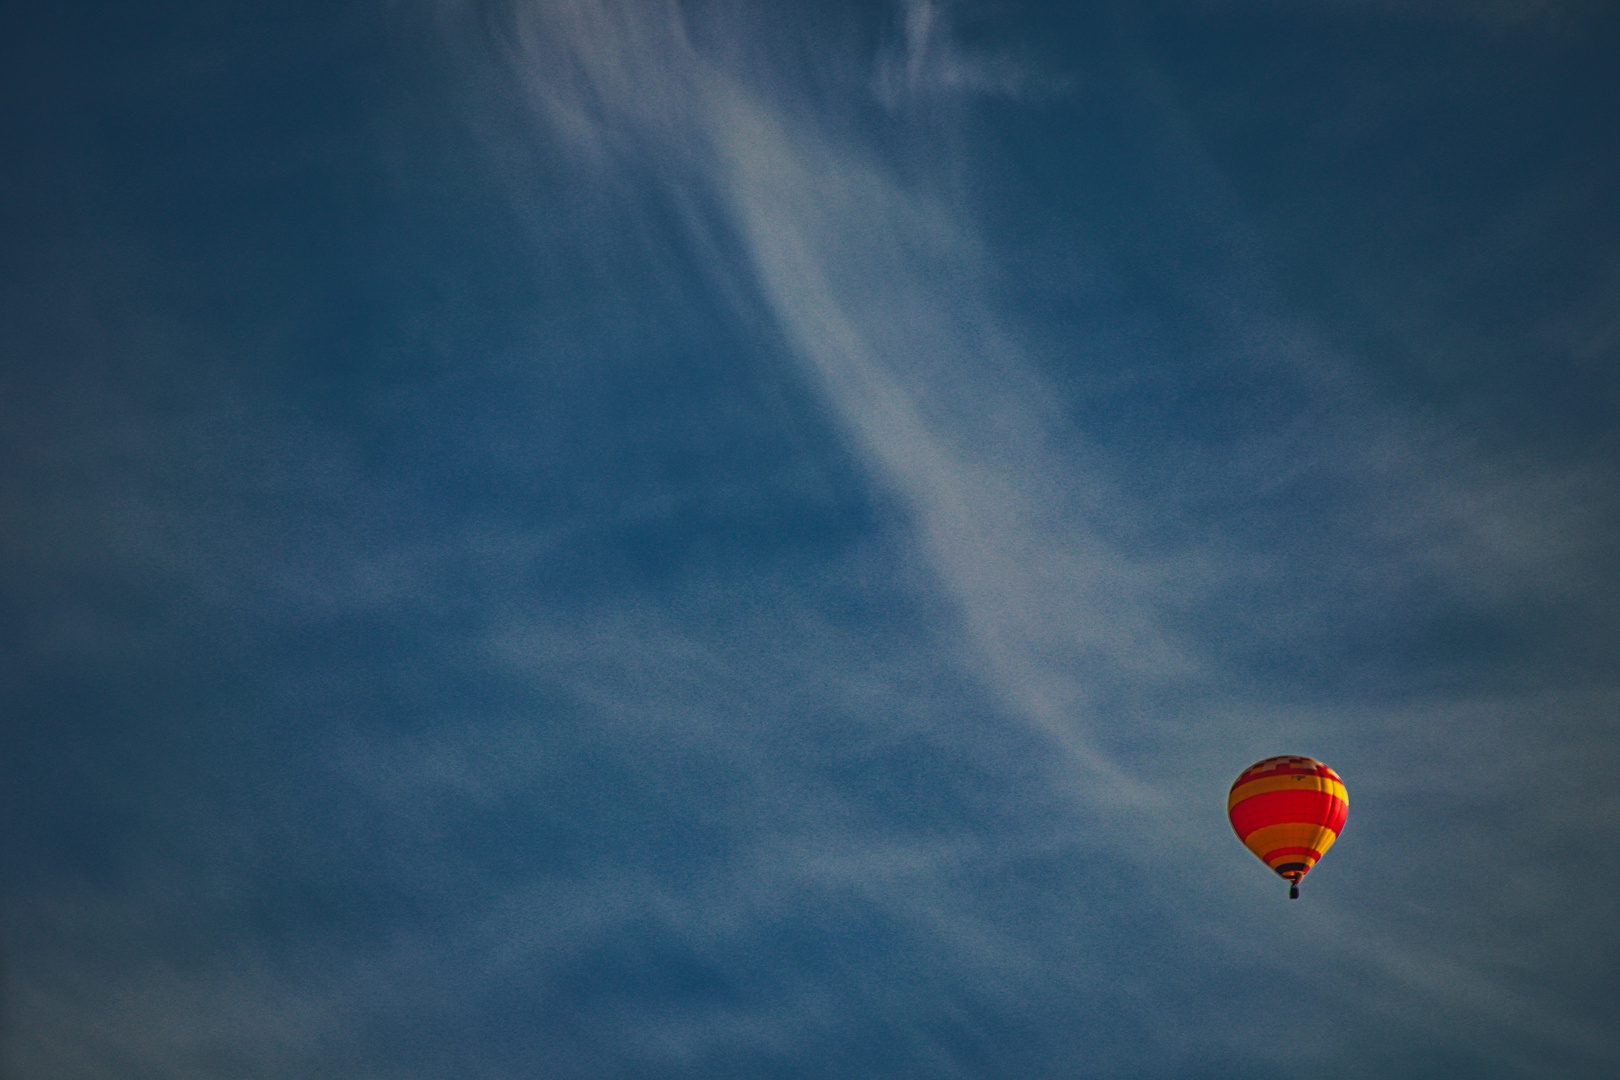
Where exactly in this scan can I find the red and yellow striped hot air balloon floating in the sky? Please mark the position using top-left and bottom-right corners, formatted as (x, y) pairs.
(1226, 756), (1349, 900)
